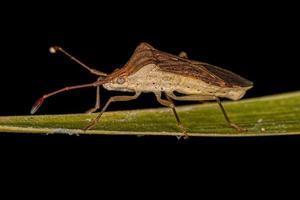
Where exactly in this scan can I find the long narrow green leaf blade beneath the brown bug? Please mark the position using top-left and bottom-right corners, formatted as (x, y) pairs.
(0, 92), (300, 137)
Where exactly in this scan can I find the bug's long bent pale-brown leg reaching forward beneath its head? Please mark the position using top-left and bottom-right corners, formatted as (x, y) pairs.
(83, 92), (141, 130)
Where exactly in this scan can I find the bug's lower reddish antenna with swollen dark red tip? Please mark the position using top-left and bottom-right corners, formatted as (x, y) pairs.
(31, 81), (98, 114)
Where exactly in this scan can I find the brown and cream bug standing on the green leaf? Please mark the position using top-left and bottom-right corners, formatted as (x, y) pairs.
(31, 43), (253, 136)
